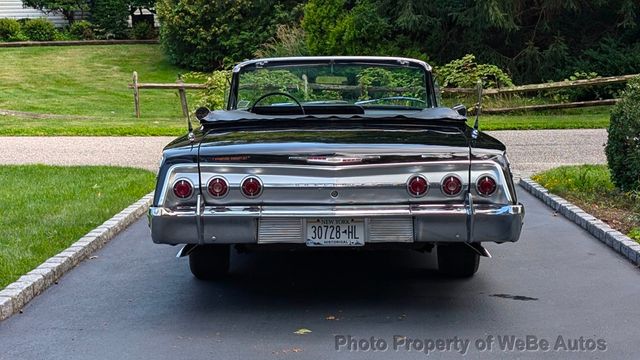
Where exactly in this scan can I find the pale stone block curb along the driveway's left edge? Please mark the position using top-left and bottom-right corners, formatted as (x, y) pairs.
(0, 192), (153, 321)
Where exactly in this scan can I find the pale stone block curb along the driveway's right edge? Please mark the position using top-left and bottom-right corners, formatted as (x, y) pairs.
(519, 178), (640, 266)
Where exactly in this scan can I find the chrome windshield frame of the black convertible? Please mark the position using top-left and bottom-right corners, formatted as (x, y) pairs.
(227, 56), (438, 110)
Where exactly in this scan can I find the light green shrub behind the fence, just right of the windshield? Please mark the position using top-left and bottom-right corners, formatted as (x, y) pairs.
(435, 55), (513, 88)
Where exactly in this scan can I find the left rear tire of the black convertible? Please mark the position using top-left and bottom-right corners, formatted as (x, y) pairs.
(189, 245), (231, 280)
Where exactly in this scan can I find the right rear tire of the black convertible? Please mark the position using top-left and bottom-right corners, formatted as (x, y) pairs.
(438, 244), (480, 278)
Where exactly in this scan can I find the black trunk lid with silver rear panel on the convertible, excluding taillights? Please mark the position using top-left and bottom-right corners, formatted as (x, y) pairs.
(199, 127), (470, 205)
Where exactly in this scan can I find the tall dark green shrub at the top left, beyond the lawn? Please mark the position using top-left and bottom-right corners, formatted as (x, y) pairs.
(91, 0), (129, 39)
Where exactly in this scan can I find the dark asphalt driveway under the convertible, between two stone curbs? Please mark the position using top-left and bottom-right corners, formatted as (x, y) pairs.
(0, 191), (640, 360)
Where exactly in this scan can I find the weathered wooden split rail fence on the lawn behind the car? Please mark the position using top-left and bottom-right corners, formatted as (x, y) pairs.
(129, 71), (640, 118)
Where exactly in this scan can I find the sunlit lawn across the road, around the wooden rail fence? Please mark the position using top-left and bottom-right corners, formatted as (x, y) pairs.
(0, 45), (609, 136)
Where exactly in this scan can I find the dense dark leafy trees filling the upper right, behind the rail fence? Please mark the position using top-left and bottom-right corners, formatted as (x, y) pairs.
(302, 0), (640, 83)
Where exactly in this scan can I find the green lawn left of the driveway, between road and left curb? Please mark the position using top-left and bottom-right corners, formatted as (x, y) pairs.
(0, 165), (154, 289)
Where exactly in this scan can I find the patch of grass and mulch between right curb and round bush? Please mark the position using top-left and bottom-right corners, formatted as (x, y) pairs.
(533, 165), (640, 242)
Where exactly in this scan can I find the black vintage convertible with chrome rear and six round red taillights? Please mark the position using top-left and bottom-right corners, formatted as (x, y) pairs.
(149, 57), (524, 279)
